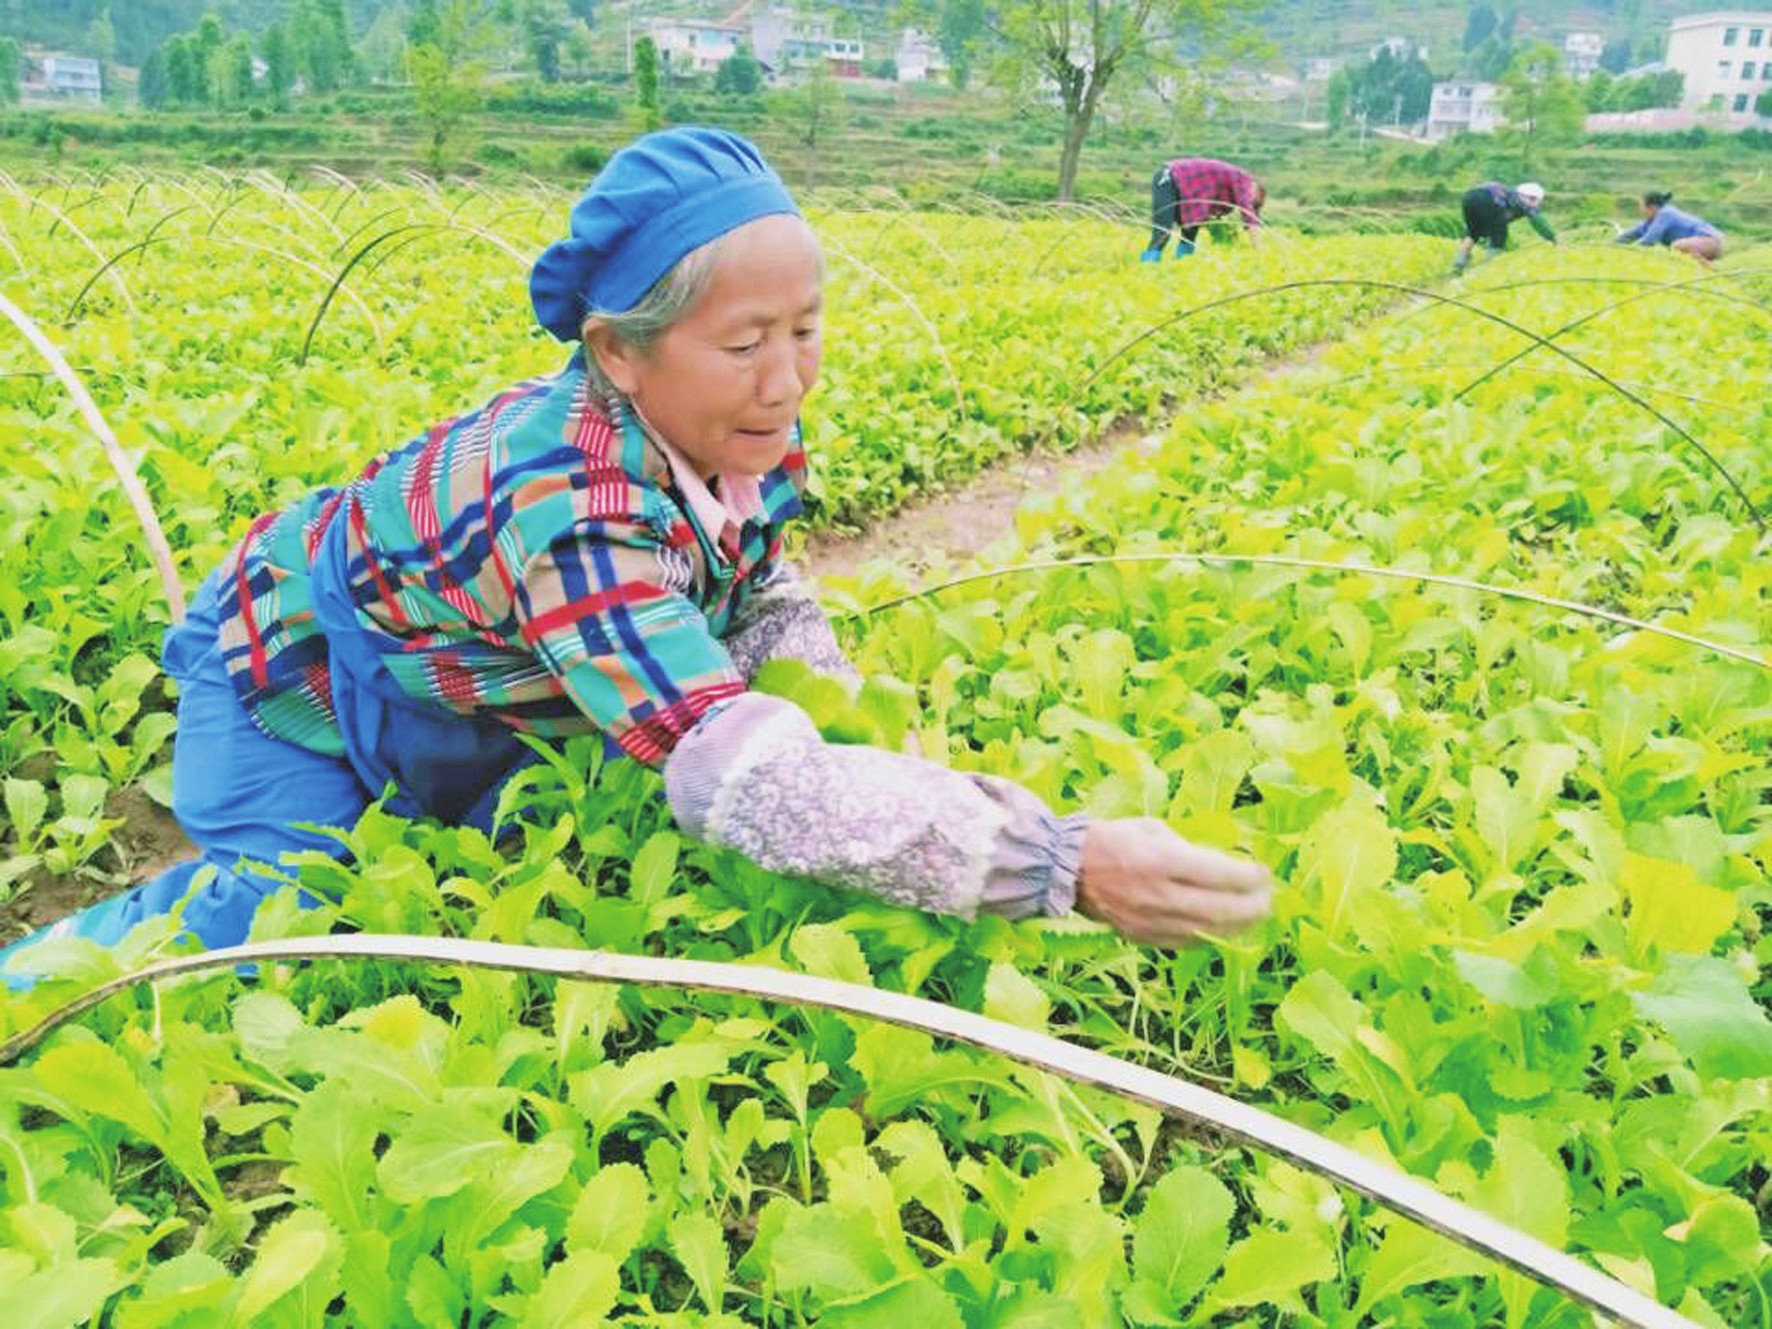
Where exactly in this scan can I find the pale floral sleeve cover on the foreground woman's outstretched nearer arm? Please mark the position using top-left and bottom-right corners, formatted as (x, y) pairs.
(665, 693), (1088, 918)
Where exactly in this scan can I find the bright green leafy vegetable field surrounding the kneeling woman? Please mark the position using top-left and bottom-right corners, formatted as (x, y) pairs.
(0, 174), (1772, 1329)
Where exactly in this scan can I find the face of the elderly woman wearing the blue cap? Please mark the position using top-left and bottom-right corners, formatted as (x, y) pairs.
(592, 216), (822, 478)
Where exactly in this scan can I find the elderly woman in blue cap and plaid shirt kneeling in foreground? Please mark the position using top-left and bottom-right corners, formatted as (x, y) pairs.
(9, 128), (1269, 976)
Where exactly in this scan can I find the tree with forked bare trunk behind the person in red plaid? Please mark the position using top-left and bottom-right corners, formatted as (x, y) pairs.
(996, 0), (1242, 198)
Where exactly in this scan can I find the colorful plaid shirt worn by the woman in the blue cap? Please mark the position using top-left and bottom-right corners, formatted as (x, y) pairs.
(220, 351), (806, 766)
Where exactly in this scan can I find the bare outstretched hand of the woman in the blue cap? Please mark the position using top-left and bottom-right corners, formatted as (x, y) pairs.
(1077, 817), (1274, 946)
